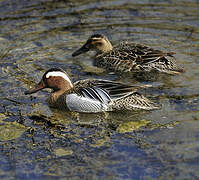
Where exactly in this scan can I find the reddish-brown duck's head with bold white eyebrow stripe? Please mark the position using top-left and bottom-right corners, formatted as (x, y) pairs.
(25, 68), (73, 94)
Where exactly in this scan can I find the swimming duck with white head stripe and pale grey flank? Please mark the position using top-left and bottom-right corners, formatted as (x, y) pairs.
(25, 68), (160, 113)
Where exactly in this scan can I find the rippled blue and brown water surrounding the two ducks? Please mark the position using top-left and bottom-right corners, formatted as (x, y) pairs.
(0, 0), (199, 179)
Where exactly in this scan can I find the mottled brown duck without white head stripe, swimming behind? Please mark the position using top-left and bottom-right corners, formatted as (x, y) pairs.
(72, 34), (184, 74)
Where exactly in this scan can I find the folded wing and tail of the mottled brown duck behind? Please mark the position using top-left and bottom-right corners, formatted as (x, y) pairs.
(115, 43), (184, 74)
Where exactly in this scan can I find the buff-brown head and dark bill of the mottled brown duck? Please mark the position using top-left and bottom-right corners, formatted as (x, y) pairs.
(72, 34), (113, 56)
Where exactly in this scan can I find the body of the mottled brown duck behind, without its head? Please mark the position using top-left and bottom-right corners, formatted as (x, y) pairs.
(95, 43), (183, 74)
